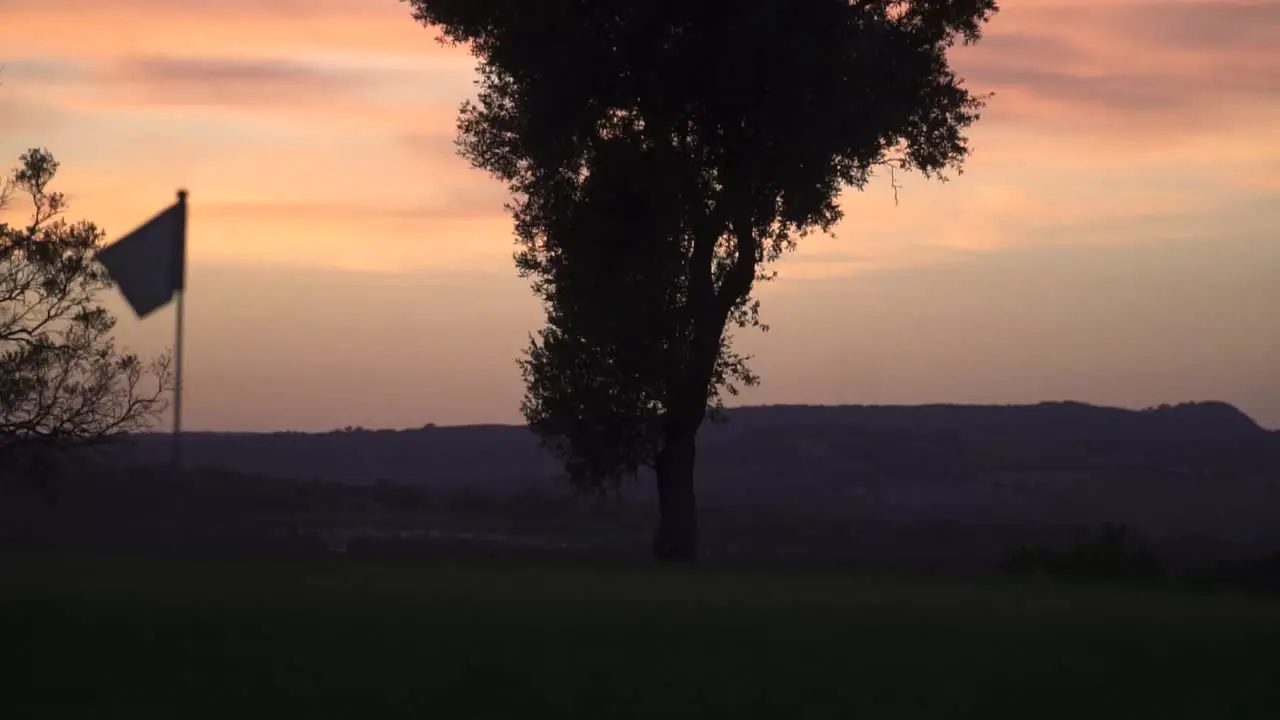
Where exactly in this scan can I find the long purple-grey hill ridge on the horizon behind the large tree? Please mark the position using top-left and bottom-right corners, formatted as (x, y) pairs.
(102, 402), (1280, 491)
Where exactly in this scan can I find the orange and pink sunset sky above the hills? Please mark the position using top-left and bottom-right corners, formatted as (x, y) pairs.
(0, 0), (1280, 429)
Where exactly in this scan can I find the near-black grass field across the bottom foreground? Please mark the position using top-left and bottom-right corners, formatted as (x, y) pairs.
(0, 545), (1280, 719)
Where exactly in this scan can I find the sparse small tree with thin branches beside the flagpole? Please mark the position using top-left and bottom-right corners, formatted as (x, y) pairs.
(0, 150), (173, 489)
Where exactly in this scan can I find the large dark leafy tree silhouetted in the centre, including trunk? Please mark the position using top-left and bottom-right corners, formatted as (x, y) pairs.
(408, 0), (996, 559)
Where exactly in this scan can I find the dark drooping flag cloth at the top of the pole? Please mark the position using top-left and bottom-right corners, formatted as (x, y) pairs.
(97, 192), (187, 318)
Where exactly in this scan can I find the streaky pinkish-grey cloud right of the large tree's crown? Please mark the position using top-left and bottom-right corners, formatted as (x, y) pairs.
(959, 0), (1280, 135)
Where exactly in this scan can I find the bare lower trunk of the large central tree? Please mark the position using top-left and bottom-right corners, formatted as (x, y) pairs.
(653, 415), (698, 562)
